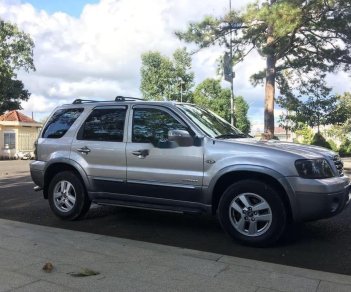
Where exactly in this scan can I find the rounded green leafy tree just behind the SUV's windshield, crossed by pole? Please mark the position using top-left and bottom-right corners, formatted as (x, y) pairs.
(193, 79), (251, 134)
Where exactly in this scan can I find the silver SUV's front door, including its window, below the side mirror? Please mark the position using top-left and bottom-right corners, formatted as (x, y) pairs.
(126, 105), (203, 202)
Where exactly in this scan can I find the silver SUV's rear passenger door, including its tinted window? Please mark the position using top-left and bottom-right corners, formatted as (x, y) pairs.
(71, 106), (127, 193)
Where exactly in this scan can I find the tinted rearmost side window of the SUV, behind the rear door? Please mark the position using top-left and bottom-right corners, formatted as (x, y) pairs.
(42, 108), (83, 139)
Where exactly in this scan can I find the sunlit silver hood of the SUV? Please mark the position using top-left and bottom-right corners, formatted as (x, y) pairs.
(217, 138), (337, 159)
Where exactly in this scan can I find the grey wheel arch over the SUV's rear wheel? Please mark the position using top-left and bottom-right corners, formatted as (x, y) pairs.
(43, 159), (89, 199)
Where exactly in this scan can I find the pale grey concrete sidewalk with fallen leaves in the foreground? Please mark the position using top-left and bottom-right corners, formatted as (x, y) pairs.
(0, 219), (351, 292)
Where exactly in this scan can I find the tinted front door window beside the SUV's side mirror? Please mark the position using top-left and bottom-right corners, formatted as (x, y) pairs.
(132, 109), (187, 144)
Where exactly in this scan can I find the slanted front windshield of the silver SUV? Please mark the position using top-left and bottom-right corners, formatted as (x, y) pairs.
(177, 104), (249, 139)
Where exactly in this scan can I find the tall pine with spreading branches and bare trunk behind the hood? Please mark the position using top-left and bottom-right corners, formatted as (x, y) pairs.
(176, 0), (351, 137)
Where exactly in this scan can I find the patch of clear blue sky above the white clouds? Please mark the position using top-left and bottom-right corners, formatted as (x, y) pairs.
(21, 0), (99, 17)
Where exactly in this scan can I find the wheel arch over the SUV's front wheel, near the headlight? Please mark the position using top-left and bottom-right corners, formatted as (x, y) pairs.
(210, 169), (295, 222)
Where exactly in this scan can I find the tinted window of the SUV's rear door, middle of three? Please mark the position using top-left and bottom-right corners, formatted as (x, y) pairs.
(78, 108), (126, 142)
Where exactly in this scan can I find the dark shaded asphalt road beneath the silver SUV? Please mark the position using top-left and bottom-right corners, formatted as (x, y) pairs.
(0, 161), (351, 275)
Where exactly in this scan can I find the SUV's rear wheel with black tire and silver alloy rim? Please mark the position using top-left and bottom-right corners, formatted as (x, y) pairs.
(48, 171), (91, 220)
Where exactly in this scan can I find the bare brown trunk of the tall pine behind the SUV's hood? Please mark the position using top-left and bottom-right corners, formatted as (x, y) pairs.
(264, 0), (276, 139)
